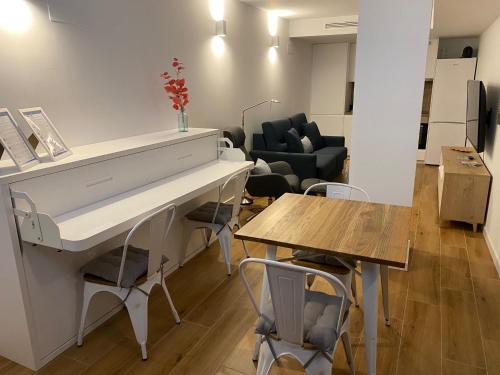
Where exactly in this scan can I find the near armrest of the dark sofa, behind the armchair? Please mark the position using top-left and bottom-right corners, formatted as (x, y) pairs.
(250, 150), (317, 181)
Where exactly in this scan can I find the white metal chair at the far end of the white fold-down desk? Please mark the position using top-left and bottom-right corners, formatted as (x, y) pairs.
(180, 171), (249, 275)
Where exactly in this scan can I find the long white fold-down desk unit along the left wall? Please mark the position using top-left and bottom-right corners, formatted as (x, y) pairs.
(0, 129), (252, 369)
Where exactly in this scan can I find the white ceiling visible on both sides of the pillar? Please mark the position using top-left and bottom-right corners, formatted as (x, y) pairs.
(242, 0), (500, 37)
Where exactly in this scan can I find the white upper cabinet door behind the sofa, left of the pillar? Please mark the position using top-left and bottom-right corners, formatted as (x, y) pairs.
(311, 43), (349, 115)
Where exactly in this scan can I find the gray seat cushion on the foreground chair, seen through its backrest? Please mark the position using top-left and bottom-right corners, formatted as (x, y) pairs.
(255, 290), (349, 353)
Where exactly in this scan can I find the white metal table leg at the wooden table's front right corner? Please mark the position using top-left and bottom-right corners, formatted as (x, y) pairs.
(361, 262), (380, 375)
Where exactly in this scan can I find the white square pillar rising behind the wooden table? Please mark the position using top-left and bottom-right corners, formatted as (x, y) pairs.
(349, 0), (432, 206)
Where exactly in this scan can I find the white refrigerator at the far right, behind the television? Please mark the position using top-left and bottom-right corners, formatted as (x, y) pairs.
(425, 58), (477, 165)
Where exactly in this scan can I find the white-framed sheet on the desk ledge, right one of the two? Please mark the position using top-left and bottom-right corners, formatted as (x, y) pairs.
(19, 107), (71, 161)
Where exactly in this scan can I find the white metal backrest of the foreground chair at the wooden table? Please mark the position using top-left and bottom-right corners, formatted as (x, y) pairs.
(240, 258), (348, 345)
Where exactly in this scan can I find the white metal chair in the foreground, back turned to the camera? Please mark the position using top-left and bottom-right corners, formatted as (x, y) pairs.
(240, 258), (354, 375)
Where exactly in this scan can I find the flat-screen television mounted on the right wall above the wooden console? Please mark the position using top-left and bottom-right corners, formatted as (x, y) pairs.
(466, 80), (488, 152)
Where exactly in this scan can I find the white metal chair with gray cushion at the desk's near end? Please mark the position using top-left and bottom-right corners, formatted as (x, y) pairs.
(77, 204), (180, 360)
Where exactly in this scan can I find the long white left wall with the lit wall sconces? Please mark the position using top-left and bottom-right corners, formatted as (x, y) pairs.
(0, 0), (311, 150)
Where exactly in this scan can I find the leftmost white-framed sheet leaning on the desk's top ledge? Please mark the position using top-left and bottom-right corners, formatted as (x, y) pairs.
(0, 108), (40, 170)
